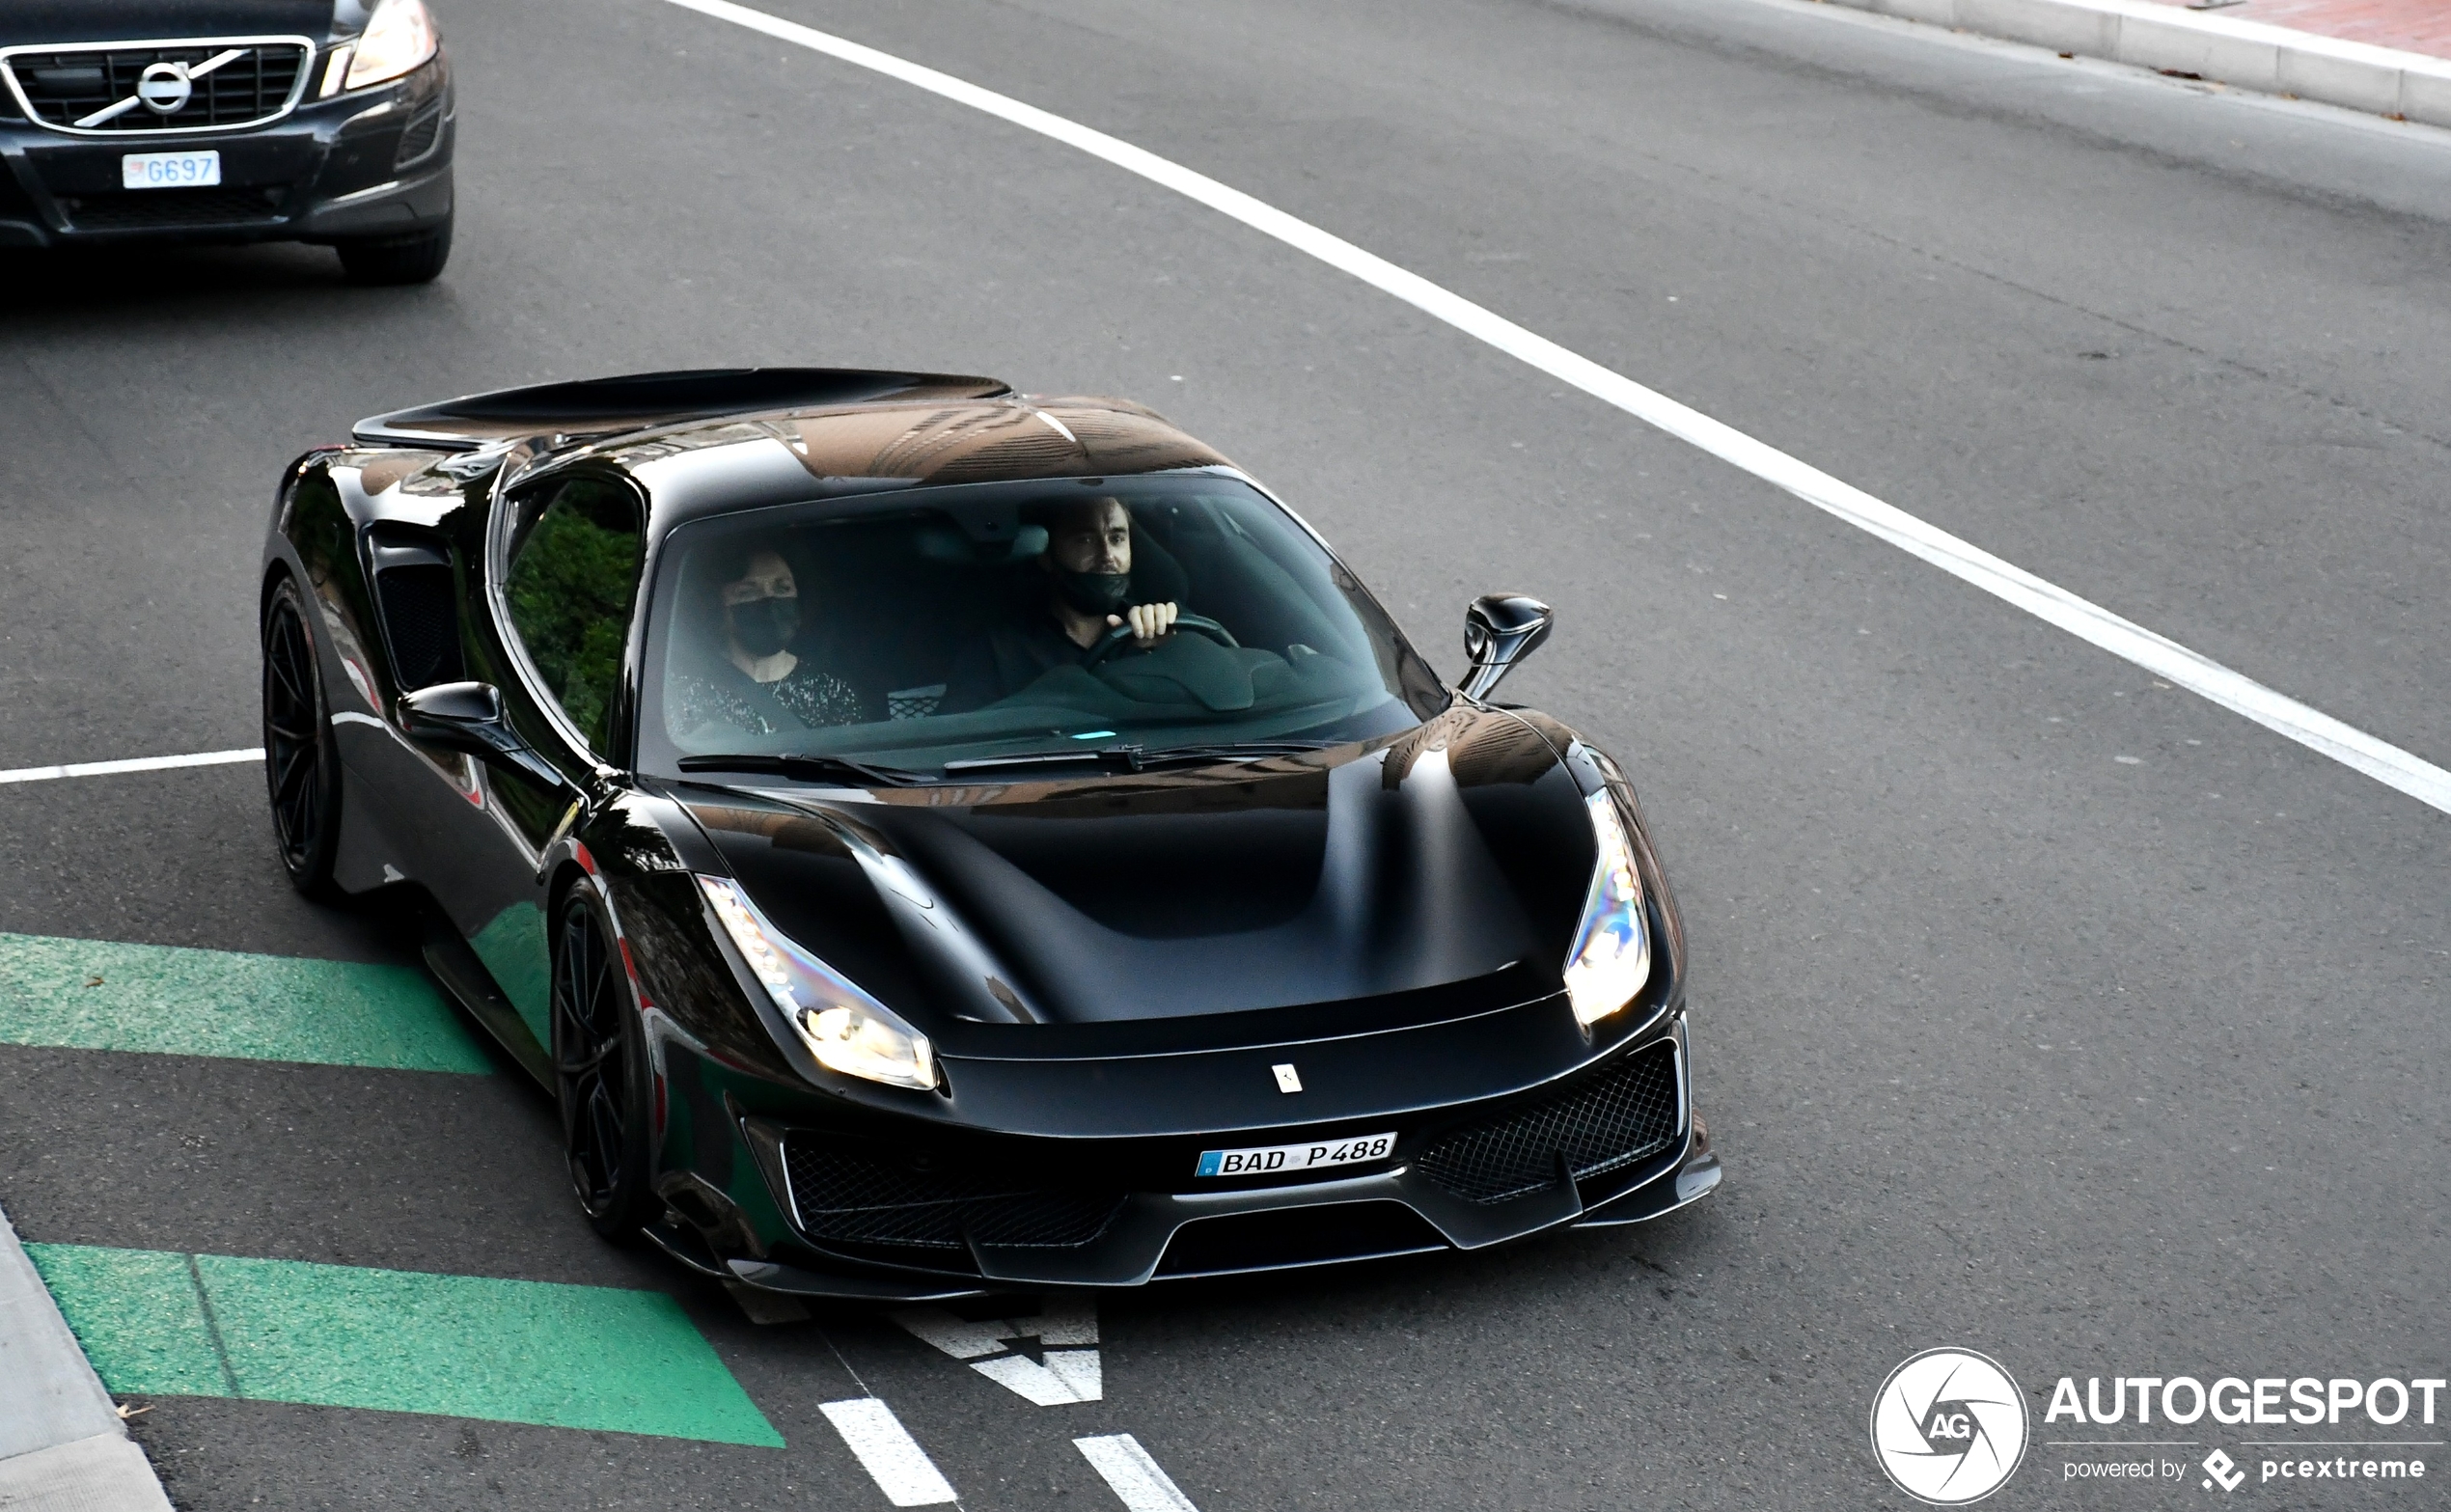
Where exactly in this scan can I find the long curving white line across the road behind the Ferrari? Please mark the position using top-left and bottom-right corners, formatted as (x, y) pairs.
(669, 0), (2451, 813)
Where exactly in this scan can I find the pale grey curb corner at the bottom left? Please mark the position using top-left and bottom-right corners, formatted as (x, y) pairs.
(0, 1213), (169, 1512)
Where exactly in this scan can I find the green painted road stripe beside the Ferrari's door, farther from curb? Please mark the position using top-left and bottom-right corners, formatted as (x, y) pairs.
(0, 934), (493, 1073)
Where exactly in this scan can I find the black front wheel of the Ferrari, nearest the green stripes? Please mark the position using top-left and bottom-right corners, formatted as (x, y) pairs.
(554, 882), (649, 1238)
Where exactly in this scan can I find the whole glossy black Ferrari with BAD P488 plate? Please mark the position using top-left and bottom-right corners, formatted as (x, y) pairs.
(262, 368), (1719, 1299)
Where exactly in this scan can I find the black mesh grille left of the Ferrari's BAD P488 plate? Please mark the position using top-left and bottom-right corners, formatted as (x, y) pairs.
(782, 1132), (1122, 1250)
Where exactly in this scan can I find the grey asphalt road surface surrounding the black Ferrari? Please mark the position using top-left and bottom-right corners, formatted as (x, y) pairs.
(0, 0), (2451, 1512)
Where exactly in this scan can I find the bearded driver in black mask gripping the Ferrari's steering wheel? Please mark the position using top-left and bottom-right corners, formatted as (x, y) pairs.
(953, 498), (1181, 708)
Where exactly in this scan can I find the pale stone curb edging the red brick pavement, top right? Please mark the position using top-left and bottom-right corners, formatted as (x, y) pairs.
(1831, 0), (2451, 125)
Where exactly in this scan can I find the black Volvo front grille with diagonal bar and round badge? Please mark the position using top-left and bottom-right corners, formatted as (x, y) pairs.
(5, 41), (312, 135)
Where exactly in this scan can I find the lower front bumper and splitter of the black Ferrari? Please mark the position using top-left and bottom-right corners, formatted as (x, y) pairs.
(649, 1012), (1721, 1302)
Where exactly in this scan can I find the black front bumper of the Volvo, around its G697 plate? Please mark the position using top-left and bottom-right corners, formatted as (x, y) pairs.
(0, 56), (458, 248)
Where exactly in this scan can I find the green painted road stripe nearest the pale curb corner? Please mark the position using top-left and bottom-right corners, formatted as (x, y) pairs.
(24, 1245), (782, 1448)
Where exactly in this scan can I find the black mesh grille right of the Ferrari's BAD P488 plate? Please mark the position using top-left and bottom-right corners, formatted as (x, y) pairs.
(1415, 1039), (1676, 1203)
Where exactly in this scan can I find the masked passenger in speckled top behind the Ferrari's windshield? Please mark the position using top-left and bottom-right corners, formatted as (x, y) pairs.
(667, 541), (875, 735)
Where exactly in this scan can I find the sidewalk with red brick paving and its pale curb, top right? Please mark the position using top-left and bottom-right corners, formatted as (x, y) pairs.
(1835, 0), (2451, 127)
